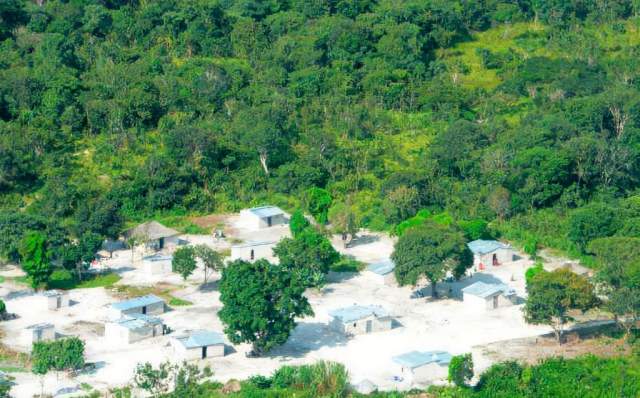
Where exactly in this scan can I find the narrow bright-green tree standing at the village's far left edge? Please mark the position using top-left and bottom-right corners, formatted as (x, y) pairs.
(19, 232), (53, 288)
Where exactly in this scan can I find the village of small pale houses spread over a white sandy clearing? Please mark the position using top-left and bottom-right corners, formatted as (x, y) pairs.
(1, 206), (584, 397)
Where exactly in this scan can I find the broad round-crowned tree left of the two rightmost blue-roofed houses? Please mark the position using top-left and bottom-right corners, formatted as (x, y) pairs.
(391, 220), (473, 297)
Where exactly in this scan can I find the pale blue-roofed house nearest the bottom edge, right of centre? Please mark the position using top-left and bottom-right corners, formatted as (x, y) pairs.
(393, 351), (452, 383)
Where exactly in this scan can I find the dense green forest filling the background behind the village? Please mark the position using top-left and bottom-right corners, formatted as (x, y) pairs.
(0, 0), (640, 260)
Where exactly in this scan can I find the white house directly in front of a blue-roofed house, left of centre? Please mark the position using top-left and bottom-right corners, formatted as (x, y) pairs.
(104, 314), (165, 345)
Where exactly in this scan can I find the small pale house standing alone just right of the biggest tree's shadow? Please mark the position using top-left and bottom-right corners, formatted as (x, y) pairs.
(329, 305), (393, 336)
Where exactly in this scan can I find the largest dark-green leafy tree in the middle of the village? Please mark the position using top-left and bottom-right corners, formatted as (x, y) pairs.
(218, 259), (313, 355)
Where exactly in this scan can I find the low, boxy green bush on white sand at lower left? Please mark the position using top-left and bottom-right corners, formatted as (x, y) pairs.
(31, 337), (84, 374)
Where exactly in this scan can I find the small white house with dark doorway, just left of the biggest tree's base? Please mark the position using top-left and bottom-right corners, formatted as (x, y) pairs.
(171, 330), (225, 360)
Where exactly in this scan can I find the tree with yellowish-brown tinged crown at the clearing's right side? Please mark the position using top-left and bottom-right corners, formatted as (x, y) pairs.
(523, 268), (599, 343)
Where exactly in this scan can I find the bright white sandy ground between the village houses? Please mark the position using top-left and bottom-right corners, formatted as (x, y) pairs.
(0, 219), (604, 397)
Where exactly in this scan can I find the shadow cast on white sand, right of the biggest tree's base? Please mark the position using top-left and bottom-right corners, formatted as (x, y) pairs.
(267, 322), (349, 358)
